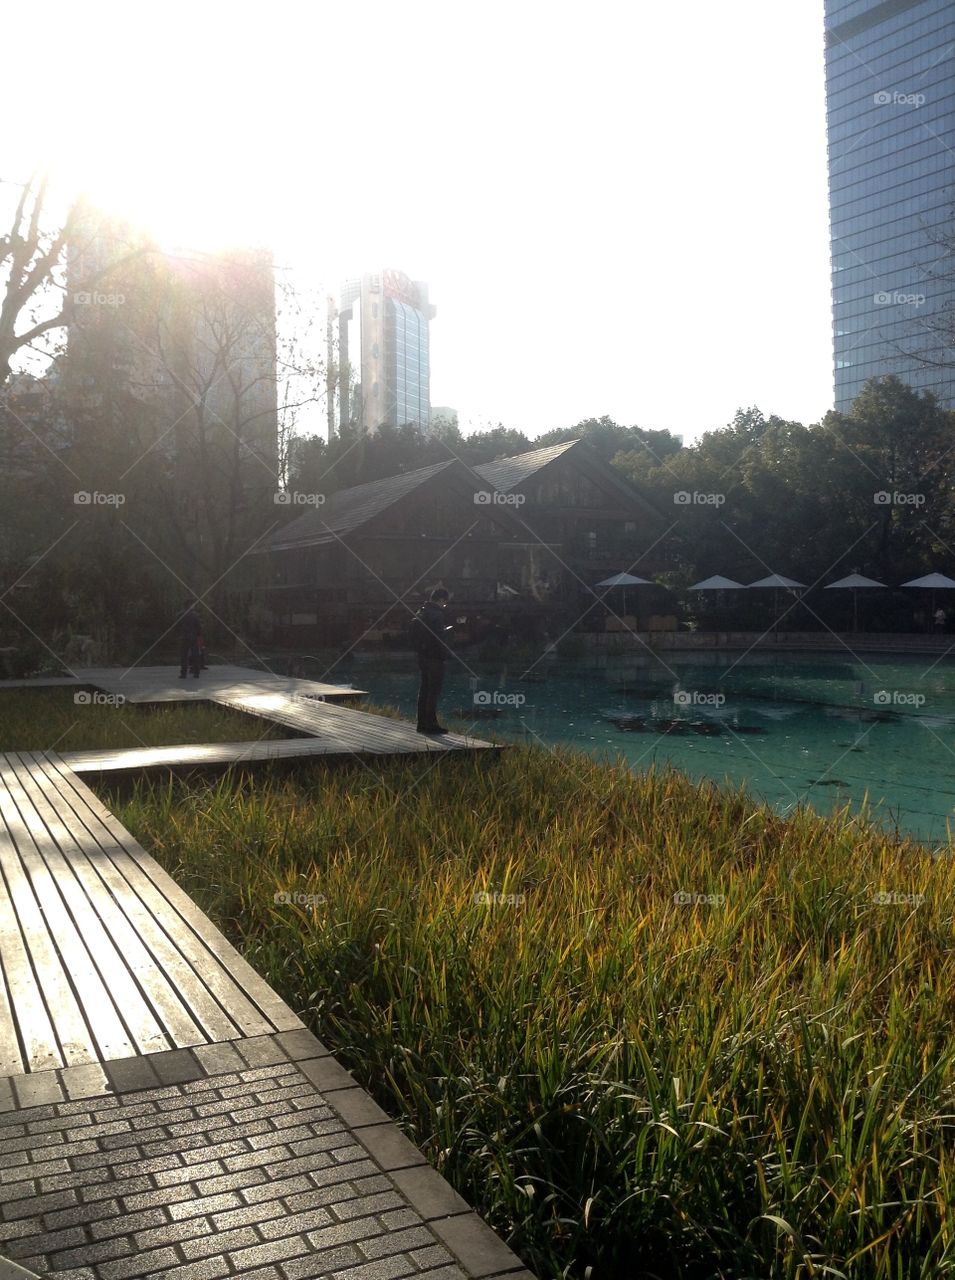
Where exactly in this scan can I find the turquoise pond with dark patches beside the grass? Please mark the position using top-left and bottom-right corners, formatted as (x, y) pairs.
(317, 653), (955, 845)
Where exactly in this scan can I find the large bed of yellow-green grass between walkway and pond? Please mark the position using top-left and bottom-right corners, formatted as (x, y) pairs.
(113, 748), (955, 1280)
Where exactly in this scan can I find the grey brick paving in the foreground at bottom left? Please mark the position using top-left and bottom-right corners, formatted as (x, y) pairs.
(0, 1032), (533, 1280)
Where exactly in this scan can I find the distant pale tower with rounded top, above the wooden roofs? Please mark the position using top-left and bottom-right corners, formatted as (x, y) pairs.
(329, 270), (437, 433)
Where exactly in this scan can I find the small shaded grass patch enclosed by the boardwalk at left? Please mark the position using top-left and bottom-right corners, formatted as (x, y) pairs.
(0, 689), (286, 751)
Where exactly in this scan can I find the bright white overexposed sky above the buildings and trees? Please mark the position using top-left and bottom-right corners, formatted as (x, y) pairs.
(0, 0), (832, 442)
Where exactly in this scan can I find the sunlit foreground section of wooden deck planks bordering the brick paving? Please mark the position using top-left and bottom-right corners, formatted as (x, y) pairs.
(0, 753), (302, 1075)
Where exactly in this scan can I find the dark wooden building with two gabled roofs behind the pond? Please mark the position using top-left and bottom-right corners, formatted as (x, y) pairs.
(269, 440), (666, 645)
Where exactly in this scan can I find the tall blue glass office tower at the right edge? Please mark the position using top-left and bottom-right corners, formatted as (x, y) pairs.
(826, 0), (955, 410)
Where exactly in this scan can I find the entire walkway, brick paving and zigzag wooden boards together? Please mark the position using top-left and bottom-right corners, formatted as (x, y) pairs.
(0, 671), (534, 1280)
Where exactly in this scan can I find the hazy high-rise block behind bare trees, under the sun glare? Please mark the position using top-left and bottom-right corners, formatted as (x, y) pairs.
(60, 216), (279, 600)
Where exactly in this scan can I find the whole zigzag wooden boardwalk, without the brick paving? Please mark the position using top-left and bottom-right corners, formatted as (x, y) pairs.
(0, 667), (493, 1076)
